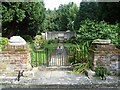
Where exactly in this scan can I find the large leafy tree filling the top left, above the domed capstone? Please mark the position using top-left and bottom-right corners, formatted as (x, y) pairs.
(2, 2), (45, 37)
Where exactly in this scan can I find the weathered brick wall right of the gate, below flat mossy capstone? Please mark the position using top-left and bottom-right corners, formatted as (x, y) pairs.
(91, 44), (120, 74)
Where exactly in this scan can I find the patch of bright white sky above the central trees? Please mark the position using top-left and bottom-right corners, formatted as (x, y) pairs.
(44, 0), (82, 10)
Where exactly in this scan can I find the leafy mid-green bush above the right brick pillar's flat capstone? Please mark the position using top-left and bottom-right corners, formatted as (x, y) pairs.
(77, 19), (118, 40)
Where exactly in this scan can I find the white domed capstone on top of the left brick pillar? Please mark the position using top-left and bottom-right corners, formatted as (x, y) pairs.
(8, 36), (26, 45)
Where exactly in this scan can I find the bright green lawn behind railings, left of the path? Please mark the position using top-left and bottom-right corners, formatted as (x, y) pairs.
(29, 44), (55, 66)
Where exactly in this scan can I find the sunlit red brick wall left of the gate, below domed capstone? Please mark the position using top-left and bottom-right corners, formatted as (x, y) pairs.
(0, 44), (31, 74)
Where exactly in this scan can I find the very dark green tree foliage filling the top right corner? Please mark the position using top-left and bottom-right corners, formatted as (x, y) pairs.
(75, 2), (120, 30)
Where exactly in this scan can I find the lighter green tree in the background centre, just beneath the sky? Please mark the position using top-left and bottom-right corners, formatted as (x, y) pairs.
(57, 2), (78, 31)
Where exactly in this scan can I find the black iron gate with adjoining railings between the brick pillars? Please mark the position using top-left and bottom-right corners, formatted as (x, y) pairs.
(31, 45), (75, 66)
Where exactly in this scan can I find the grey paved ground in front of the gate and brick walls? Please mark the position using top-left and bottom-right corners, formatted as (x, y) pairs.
(0, 71), (119, 88)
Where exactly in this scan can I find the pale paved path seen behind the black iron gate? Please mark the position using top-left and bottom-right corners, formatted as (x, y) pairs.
(48, 45), (68, 66)
